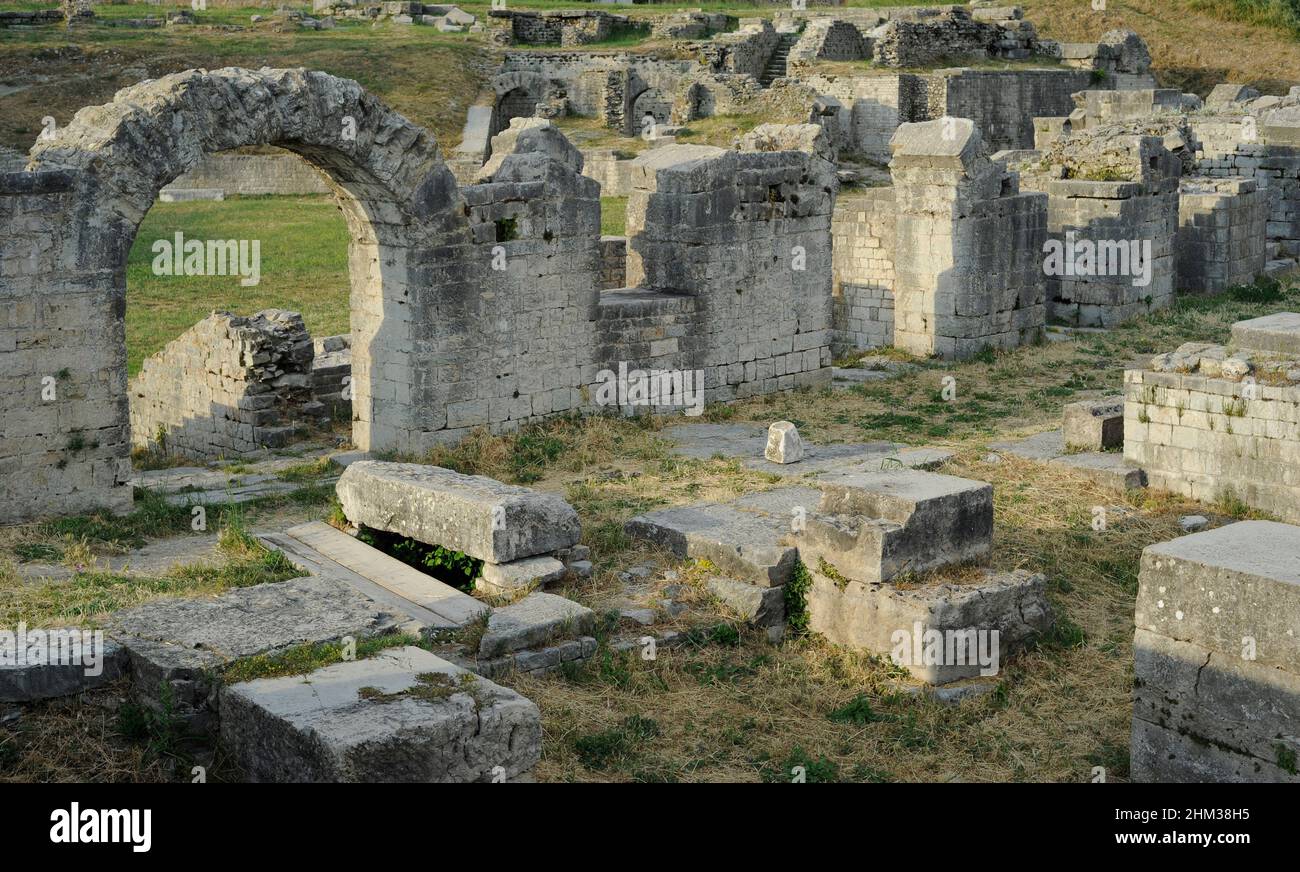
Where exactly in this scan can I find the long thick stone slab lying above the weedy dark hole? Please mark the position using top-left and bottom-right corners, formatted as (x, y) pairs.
(337, 460), (581, 563)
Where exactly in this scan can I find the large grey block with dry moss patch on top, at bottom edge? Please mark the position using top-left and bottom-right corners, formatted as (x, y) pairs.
(221, 647), (542, 784)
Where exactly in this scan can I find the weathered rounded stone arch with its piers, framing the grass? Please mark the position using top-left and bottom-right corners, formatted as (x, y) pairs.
(20, 68), (459, 504)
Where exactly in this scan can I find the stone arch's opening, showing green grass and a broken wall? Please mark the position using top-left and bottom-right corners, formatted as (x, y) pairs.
(126, 147), (352, 462)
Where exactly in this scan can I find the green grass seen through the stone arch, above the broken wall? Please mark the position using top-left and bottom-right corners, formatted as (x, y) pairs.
(126, 195), (348, 376)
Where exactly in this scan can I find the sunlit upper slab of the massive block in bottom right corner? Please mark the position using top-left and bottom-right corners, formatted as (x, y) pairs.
(1134, 521), (1300, 674)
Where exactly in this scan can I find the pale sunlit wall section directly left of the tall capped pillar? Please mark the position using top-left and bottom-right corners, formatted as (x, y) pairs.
(831, 187), (896, 355)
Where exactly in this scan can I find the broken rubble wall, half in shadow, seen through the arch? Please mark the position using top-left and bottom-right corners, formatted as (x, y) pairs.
(130, 309), (315, 460)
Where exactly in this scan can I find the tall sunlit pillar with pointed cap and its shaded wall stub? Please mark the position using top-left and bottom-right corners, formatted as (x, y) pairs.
(891, 118), (1048, 359)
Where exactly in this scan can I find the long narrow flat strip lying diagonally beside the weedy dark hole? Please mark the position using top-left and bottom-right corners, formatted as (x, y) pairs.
(285, 521), (488, 626)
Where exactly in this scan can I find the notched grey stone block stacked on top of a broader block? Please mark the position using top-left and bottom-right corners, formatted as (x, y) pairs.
(794, 469), (993, 582)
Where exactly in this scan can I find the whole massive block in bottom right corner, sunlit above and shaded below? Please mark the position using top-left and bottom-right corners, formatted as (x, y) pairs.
(1130, 521), (1300, 782)
